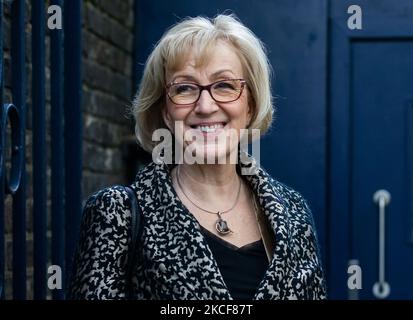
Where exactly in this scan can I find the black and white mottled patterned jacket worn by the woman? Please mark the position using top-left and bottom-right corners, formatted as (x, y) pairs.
(69, 163), (326, 299)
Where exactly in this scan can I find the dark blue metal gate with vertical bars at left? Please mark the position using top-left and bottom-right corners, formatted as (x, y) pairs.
(0, 0), (82, 299)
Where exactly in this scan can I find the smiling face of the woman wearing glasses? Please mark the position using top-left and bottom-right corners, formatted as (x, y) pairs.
(162, 41), (251, 163)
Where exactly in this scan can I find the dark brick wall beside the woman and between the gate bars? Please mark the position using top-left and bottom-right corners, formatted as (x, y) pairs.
(3, 0), (134, 299)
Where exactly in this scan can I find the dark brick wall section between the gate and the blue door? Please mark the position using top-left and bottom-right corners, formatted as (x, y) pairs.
(82, 0), (133, 196)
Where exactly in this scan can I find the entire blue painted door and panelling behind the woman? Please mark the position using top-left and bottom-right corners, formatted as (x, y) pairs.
(133, 0), (413, 299)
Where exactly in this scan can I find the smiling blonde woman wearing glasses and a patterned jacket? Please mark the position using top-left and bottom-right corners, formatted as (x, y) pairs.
(70, 15), (325, 299)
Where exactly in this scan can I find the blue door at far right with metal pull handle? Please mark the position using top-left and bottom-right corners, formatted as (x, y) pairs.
(329, 1), (413, 299)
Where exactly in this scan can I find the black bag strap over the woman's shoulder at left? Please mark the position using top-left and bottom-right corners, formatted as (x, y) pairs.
(125, 186), (143, 299)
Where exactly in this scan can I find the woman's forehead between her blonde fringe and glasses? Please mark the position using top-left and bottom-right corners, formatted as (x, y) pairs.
(166, 40), (243, 79)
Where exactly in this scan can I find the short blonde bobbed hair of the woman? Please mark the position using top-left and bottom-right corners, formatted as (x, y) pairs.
(132, 14), (273, 152)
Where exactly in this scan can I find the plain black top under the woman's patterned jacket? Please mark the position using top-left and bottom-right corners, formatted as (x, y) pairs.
(201, 227), (268, 300)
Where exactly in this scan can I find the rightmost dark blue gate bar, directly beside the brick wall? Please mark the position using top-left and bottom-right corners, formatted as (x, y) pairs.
(63, 0), (82, 284)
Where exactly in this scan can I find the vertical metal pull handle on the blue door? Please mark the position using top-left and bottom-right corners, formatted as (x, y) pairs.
(373, 189), (391, 299)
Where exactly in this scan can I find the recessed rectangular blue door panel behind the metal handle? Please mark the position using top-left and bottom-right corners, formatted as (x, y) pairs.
(351, 40), (413, 299)
